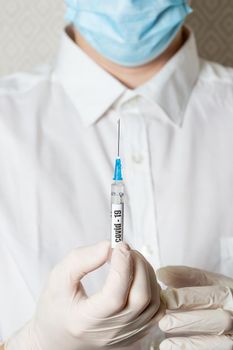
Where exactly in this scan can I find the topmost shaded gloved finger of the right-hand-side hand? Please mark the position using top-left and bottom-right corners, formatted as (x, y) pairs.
(156, 266), (233, 288)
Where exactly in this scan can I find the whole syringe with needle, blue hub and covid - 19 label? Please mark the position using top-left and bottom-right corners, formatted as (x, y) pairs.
(111, 120), (125, 248)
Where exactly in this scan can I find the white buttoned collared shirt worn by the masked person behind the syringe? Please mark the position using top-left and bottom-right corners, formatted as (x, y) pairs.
(0, 26), (233, 350)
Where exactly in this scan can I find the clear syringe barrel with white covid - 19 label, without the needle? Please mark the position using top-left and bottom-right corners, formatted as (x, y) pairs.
(111, 181), (124, 248)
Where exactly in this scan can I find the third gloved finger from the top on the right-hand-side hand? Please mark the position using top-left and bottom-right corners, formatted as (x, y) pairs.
(159, 309), (233, 335)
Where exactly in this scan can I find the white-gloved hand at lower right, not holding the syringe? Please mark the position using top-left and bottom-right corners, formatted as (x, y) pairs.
(157, 267), (233, 350)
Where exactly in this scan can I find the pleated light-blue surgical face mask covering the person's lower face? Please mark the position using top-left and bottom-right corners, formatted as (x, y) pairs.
(65, 0), (191, 67)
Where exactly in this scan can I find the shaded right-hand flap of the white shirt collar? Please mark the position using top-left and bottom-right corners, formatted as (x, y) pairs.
(137, 27), (200, 127)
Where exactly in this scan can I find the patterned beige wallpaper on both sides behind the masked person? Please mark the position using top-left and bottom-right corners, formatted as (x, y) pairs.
(0, 0), (233, 75)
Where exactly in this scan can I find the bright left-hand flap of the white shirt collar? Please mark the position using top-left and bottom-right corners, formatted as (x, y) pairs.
(53, 27), (127, 126)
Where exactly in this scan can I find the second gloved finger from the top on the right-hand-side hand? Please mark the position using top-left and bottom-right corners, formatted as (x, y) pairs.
(161, 286), (233, 311)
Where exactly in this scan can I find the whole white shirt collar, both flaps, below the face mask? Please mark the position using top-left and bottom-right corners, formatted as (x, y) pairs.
(53, 28), (200, 126)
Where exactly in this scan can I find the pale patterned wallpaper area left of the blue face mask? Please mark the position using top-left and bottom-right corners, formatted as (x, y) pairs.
(0, 0), (64, 75)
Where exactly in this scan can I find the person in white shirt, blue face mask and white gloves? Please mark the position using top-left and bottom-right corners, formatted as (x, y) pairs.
(0, 0), (233, 350)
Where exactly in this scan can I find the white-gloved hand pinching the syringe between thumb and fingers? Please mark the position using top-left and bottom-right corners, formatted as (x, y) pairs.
(5, 242), (164, 350)
